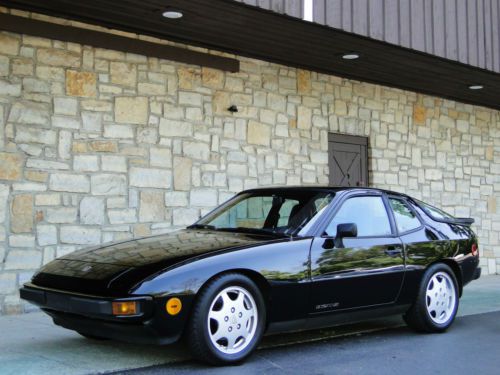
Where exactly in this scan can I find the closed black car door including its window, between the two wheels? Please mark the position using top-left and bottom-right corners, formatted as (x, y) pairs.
(310, 192), (404, 314)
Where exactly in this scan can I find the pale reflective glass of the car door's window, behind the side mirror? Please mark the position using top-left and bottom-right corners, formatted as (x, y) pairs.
(326, 197), (391, 237)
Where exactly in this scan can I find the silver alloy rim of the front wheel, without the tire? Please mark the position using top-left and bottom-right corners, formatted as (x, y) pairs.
(207, 286), (259, 354)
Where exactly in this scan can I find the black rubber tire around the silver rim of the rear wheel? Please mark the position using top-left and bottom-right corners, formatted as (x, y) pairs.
(419, 263), (459, 332)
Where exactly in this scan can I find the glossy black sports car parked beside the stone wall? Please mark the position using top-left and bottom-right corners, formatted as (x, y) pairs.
(21, 187), (481, 364)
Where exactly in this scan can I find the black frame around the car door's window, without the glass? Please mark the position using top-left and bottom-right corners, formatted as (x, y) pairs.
(318, 190), (398, 239)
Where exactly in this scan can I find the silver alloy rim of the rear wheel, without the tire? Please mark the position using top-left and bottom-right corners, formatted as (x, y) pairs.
(425, 271), (456, 324)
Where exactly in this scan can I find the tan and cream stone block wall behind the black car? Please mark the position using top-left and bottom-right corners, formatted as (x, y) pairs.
(0, 8), (500, 313)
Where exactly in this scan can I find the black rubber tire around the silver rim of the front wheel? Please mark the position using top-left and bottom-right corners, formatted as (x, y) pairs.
(194, 274), (266, 364)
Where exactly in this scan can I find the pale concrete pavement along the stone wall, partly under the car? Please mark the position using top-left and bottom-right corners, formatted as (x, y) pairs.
(0, 276), (500, 375)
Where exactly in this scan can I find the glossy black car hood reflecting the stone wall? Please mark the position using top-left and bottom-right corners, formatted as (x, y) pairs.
(32, 229), (287, 296)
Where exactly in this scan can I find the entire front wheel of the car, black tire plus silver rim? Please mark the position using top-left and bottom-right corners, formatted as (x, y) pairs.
(188, 274), (266, 365)
